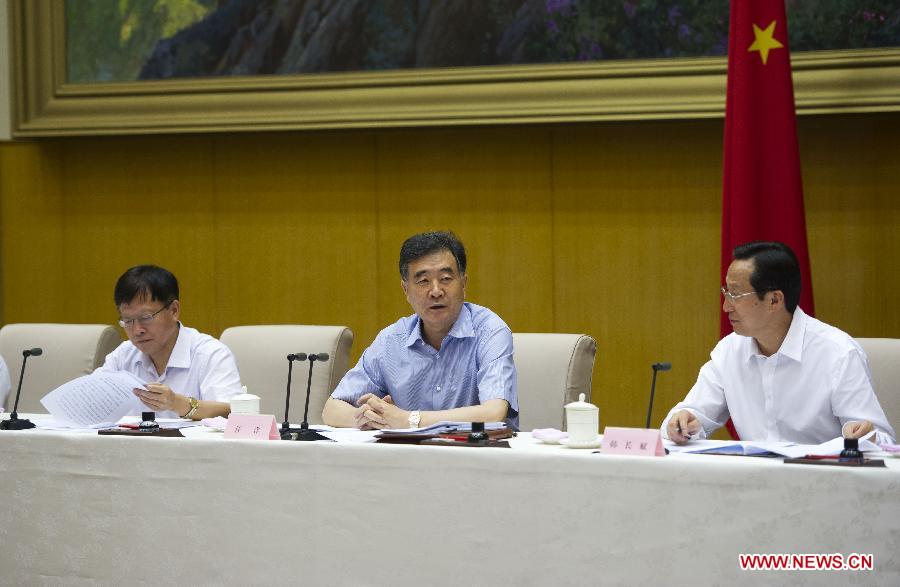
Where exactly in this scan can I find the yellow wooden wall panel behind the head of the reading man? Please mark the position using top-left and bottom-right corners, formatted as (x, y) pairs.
(61, 137), (219, 331)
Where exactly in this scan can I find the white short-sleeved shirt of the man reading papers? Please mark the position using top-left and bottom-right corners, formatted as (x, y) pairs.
(94, 322), (241, 418)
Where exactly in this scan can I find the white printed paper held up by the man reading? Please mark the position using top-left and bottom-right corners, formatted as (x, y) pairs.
(41, 371), (149, 428)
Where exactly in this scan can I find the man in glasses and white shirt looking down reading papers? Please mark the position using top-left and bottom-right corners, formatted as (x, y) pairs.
(95, 265), (241, 420)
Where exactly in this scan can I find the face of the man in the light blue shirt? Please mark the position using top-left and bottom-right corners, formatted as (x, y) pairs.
(400, 249), (467, 332)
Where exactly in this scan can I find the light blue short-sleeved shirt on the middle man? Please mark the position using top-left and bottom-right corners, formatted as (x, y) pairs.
(331, 302), (519, 429)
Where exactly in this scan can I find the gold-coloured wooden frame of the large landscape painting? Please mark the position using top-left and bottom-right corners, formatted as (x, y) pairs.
(10, 0), (900, 138)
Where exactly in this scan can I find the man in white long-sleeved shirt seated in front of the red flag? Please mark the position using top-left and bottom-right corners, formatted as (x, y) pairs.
(662, 242), (894, 444)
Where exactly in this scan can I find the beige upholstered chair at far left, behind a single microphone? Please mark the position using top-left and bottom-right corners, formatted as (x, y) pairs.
(0, 324), (122, 413)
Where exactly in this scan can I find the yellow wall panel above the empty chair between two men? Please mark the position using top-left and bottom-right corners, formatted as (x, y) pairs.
(214, 134), (378, 351)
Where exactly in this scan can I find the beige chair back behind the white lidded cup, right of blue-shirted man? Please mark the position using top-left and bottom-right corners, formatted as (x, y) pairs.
(513, 332), (597, 430)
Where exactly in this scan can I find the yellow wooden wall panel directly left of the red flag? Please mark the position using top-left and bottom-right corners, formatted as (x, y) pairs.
(553, 123), (721, 427)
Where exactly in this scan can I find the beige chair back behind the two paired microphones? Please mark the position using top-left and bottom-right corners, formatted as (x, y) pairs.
(220, 324), (353, 424)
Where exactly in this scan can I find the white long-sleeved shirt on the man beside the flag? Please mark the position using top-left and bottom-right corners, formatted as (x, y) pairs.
(662, 307), (894, 444)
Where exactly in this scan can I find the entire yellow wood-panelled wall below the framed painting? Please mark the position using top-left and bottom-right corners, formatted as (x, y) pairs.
(0, 115), (900, 426)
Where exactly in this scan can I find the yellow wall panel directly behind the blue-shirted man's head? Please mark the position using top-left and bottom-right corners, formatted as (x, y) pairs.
(378, 129), (553, 332)
